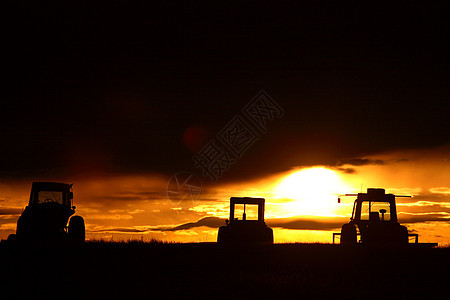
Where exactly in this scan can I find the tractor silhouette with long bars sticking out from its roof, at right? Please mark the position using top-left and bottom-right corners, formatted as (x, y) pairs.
(333, 188), (437, 247)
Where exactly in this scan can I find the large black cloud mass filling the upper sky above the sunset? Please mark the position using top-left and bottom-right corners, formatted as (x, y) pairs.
(0, 1), (450, 181)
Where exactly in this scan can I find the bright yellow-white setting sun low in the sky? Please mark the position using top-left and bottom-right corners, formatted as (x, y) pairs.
(274, 167), (351, 216)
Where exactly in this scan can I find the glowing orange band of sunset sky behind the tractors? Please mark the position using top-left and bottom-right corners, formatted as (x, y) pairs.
(0, 146), (450, 244)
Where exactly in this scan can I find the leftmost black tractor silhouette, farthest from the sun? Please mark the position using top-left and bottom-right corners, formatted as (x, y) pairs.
(8, 182), (85, 244)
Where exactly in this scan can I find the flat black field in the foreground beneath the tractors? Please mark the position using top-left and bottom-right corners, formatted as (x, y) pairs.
(0, 242), (450, 299)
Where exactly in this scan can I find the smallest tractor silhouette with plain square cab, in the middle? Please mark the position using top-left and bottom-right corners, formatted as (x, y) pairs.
(217, 197), (273, 245)
